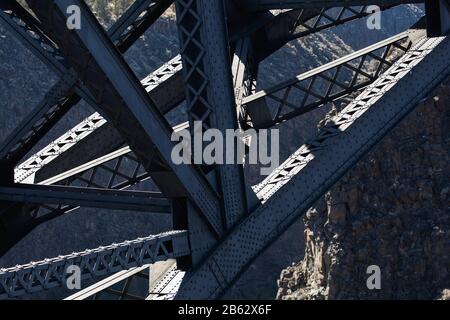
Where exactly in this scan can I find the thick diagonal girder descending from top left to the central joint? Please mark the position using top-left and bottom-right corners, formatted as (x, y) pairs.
(23, 0), (223, 234)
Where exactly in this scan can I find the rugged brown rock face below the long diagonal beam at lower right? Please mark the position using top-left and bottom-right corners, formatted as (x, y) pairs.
(278, 79), (450, 299)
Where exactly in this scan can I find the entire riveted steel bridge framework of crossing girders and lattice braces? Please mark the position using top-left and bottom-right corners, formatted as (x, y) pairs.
(0, 0), (450, 299)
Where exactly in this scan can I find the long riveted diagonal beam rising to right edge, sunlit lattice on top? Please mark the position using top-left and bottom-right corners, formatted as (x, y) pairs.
(177, 33), (450, 299)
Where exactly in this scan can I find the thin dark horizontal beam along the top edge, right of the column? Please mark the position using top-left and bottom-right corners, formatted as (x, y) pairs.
(241, 0), (425, 12)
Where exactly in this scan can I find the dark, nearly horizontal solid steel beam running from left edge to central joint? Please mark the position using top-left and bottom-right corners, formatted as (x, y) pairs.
(0, 184), (171, 213)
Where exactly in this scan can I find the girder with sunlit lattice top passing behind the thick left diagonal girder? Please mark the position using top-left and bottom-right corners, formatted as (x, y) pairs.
(15, 57), (184, 182)
